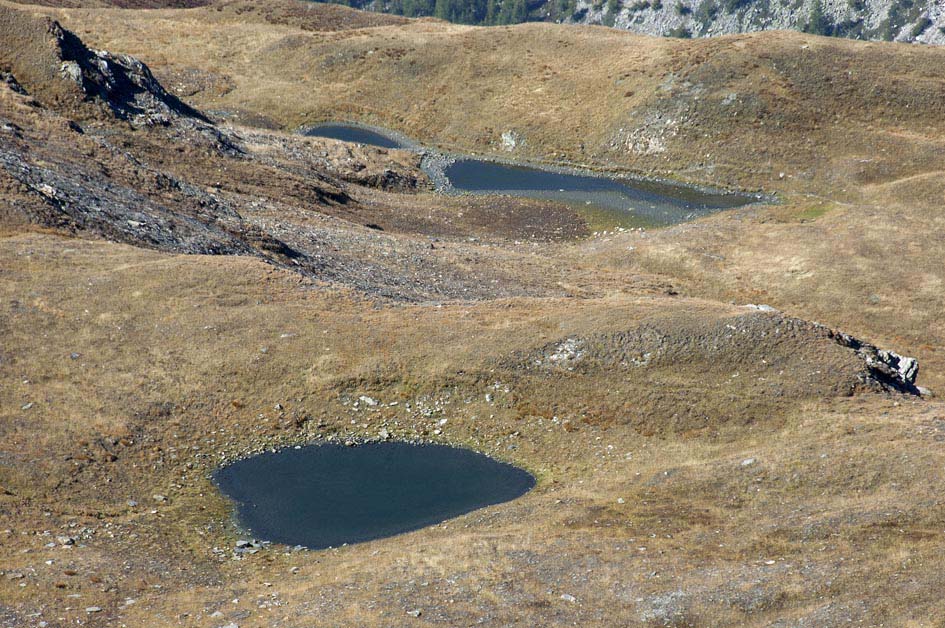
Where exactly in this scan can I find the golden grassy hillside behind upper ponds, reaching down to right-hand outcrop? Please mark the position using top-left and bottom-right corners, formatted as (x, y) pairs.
(42, 2), (945, 386)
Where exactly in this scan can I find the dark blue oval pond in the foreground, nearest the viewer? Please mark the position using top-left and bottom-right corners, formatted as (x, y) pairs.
(214, 443), (535, 549)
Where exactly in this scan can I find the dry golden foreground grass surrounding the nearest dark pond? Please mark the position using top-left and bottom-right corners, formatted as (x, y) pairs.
(0, 235), (945, 626)
